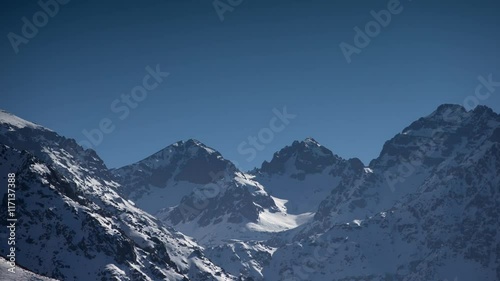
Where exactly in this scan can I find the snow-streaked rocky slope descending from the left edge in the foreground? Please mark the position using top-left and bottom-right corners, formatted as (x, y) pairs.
(0, 112), (233, 280)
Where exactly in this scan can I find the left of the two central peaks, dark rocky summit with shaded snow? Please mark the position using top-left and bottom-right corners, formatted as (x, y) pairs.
(112, 139), (239, 213)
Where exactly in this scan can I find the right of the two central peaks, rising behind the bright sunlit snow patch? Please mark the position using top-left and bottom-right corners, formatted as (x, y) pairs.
(252, 137), (364, 212)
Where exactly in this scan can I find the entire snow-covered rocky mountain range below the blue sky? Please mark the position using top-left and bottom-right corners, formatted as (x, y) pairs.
(0, 105), (500, 281)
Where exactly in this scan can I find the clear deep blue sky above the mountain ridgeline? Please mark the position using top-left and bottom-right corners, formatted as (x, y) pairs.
(0, 0), (500, 169)
